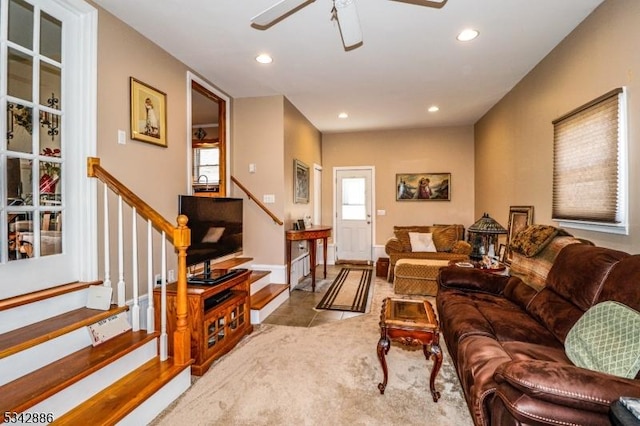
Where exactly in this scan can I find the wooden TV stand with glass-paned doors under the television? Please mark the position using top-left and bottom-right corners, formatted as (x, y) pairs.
(153, 270), (253, 376)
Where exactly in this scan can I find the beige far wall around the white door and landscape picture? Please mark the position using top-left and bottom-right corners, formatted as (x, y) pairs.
(322, 126), (475, 245)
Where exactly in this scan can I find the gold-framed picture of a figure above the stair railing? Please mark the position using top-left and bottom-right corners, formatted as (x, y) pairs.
(130, 77), (167, 148)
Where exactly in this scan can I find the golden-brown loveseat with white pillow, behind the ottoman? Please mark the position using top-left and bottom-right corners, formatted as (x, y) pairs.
(384, 225), (471, 282)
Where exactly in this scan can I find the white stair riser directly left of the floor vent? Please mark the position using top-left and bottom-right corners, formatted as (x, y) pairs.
(0, 327), (91, 385)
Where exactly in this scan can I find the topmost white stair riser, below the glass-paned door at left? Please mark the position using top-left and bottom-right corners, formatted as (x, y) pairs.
(0, 289), (88, 334)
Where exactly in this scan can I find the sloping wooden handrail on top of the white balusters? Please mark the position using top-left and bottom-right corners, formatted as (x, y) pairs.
(87, 157), (175, 243)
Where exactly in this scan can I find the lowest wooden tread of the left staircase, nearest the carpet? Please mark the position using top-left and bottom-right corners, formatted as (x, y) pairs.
(51, 357), (189, 425)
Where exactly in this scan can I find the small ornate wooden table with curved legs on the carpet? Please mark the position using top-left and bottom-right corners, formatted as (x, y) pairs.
(378, 297), (442, 402)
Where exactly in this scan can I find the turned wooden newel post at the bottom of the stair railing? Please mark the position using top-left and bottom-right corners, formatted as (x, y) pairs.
(173, 215), (191, 365)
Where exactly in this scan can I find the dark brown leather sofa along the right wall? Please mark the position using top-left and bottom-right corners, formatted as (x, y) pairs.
(436, 244), (640, 426)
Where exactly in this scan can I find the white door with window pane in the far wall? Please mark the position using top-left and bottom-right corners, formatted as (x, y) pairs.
(335, 168), (373, 261)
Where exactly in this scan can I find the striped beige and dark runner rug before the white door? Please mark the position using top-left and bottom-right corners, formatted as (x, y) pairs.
(316, 268), (373, 313)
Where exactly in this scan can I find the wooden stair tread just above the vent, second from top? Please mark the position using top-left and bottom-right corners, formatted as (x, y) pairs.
(0, 305), (129, 358)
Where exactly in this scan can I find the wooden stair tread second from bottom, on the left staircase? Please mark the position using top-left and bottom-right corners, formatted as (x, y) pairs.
(0, 330), (158, 412)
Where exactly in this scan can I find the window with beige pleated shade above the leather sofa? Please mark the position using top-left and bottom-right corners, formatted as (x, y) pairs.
(552, 88), (628, 235)
